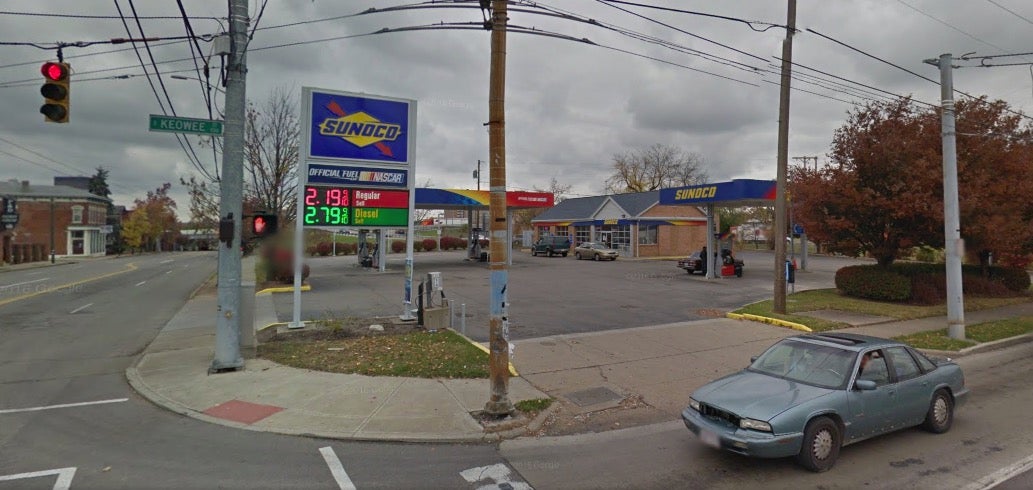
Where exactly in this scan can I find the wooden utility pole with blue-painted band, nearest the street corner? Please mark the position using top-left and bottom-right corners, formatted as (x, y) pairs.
(481, 0), (513, 417)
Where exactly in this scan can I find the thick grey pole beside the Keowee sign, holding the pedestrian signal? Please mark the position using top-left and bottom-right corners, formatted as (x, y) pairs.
(209, 0), (248, 372)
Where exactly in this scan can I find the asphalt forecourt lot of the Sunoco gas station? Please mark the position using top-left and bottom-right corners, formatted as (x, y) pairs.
(274, 250), (864, 341)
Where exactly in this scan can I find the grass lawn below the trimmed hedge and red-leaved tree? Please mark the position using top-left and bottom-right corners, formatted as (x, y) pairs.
(734, 289), (1030, 332)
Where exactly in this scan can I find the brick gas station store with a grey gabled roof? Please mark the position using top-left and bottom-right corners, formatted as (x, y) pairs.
(531, 190), (720, 257)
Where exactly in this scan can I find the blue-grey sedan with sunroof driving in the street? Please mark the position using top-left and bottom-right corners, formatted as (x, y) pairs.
(682, 333), (969, 471)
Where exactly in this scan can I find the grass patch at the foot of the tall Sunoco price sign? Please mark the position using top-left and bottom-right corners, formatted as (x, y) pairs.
(258, 330), (488, 378)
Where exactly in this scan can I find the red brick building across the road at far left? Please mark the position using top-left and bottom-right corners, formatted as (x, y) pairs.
(0, 180), (111, 264)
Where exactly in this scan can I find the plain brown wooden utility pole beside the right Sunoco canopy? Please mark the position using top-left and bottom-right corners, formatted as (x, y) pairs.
(774, 0), (796, 313)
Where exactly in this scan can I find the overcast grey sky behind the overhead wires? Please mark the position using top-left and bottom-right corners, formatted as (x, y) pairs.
(0, 0), (1033, 217)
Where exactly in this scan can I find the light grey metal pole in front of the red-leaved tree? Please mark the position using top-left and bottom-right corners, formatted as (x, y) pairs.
(939, 54), (965, 339)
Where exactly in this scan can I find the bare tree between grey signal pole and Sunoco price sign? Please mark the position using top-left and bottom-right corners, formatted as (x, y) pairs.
(244, 88), (300, 220)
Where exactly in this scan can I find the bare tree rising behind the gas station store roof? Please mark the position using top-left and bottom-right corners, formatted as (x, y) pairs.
(606, 143), (707, 193)
